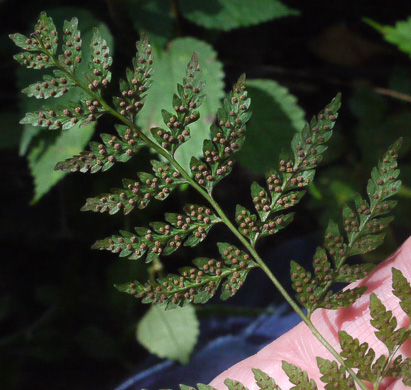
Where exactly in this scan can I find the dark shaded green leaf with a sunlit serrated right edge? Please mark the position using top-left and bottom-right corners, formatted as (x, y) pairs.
(237, 79), (305, 173)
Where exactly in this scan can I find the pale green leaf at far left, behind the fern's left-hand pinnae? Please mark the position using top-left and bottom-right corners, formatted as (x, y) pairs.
(27, 123), (95, 203)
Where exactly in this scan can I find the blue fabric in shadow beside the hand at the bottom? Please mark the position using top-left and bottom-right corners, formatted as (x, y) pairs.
(115, 306), (300, 390)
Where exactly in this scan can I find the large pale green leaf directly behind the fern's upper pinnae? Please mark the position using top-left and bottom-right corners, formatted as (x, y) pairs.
(137, 38), (224, 168)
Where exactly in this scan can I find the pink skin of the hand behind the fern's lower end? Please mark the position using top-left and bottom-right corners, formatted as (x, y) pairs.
(210, 237), (411, 390)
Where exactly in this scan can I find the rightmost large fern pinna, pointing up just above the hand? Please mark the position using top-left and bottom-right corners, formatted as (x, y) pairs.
(292, 139), (401, 316)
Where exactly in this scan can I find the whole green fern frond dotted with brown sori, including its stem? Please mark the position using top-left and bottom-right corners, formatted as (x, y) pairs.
(10, 13), (411, 390)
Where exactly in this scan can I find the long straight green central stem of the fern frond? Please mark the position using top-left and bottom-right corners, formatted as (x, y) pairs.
(42, 45), (368, 390)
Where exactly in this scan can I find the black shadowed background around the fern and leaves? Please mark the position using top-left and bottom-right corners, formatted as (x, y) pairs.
(0, 0), (411, 390)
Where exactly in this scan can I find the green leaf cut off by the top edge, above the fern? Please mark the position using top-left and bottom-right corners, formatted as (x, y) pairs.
(180, 0), (299, 31)
